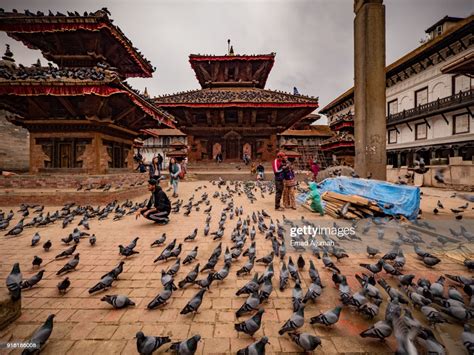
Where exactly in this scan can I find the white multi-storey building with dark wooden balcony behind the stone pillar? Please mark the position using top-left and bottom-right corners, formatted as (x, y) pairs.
(320, 16), (474, 173)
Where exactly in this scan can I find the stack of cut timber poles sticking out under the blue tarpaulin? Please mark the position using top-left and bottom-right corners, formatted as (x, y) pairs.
(321, 191), (384, 219)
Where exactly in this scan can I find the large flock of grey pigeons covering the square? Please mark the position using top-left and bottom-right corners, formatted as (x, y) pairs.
(0, 180), (474, 354)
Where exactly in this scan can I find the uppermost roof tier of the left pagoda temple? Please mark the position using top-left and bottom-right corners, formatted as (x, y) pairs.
(0, 8), (155, 78)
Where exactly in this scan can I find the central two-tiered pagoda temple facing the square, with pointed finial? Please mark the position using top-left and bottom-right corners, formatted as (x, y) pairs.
(154, 50), (318, 161)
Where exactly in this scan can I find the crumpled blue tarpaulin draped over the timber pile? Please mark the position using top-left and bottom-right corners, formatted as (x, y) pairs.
(318, 176), (420, 219)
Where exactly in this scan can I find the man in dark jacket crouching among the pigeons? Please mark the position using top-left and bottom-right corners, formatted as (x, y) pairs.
(136, 179), (171, 224)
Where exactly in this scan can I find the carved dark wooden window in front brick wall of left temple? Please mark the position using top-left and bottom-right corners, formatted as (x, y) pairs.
(36, 138), (91, 169)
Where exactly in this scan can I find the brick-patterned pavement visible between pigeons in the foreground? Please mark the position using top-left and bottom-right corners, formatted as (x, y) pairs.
(0, 182), (467, 354)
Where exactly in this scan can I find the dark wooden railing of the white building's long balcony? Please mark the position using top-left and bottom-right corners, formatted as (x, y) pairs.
(387, 89), (474, 123)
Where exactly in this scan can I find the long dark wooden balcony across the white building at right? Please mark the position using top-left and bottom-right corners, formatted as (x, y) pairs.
(387, 89), (474, 126)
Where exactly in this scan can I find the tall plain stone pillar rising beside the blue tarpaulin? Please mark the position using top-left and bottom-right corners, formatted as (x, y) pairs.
(354, 0), (387, 180)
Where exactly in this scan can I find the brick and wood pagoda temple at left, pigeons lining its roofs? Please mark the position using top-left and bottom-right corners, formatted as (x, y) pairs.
(0, 8), (174, 174)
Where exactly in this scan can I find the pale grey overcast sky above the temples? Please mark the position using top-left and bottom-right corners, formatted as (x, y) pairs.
(0, 0), (474, 124)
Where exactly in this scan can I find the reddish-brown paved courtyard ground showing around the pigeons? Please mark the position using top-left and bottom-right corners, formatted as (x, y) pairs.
(0, 181), (474, 354)
